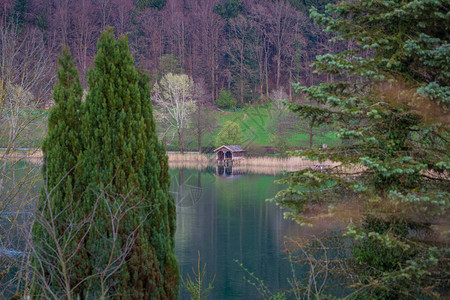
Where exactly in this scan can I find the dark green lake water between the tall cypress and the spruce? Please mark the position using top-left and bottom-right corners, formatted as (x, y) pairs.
(170, 169), (301, 299)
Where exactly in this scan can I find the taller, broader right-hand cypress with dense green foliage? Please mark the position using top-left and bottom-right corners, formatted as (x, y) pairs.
(80, 29), (179, 299)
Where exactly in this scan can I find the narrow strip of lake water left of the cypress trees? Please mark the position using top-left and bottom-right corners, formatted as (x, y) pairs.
(0, 159), (41, 299)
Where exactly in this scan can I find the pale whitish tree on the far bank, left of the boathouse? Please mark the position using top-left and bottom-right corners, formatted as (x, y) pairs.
(152, 73), (196, 153)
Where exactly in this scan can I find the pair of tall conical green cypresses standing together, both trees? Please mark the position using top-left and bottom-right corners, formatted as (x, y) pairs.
(33, 29), (179, 299)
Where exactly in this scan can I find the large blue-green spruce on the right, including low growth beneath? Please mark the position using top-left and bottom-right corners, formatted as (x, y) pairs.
(278, 0), (450, 299)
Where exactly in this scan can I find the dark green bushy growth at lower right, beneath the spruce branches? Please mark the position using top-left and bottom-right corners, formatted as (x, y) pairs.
(346, 216), (446, 299)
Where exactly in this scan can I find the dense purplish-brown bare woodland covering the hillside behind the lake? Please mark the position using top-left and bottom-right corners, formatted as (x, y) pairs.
(0, 0), (338, 104)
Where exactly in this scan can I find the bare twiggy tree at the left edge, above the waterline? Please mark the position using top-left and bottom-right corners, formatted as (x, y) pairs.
(0, 24), (54, 154)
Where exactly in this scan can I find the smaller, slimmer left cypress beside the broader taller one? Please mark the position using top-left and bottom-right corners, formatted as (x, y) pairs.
(33, 47), (83, 298)
